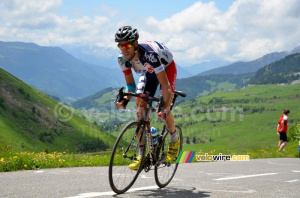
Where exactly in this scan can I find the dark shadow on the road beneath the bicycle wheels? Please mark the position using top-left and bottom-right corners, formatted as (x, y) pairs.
(114, 186), (210, 198)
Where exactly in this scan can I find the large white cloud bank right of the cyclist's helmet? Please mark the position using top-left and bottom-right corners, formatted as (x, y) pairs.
(141, 0), (300, 63)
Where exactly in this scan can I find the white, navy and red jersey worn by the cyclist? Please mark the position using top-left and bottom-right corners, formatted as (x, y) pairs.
(118, 41), (173, 75)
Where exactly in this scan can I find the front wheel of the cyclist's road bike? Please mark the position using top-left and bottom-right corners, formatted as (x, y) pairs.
(109, 122), (145, 194)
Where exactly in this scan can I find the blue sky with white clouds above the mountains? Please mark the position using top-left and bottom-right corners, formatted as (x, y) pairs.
(0, 0), (300, 66)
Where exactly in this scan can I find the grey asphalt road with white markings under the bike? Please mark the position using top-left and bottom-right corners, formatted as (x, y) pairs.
(0, 158), (300, 198)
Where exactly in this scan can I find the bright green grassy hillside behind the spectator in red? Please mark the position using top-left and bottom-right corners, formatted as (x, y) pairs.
(172, 84), (300, 152)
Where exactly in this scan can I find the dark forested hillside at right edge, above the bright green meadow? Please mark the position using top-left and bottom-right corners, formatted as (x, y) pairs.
(249, 53), (300, 85)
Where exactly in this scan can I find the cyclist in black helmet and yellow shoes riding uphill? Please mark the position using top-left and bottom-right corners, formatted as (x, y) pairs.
(115, 26), (180, 169)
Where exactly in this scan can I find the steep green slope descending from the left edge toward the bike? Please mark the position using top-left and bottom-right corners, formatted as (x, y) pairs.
(0, 69), (115, 152)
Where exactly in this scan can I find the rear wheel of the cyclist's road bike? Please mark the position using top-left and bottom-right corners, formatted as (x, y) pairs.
(154, 125), (182, 188)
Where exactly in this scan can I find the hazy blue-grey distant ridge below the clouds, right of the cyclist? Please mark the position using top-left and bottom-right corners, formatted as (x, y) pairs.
(198, 52), (288, 76)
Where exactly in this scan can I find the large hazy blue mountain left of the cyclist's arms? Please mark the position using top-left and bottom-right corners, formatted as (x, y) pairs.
(0, 42), (124, 100)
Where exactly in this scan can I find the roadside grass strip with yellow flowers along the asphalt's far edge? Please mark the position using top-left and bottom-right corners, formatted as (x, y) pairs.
(0, 141), (299, 172)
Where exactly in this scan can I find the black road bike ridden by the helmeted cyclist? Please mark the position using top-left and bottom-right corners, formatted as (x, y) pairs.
(109, 87), (186, 194)
